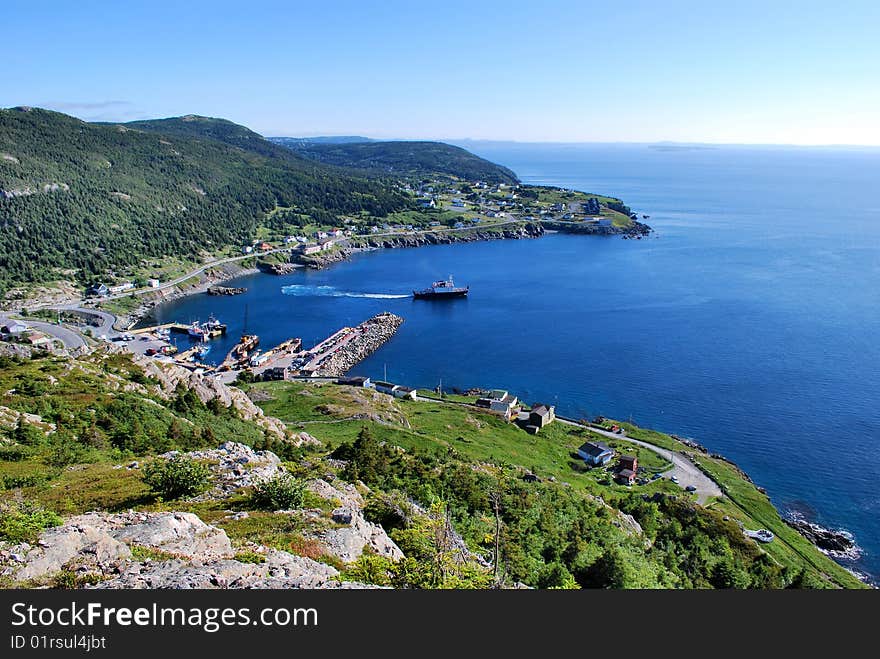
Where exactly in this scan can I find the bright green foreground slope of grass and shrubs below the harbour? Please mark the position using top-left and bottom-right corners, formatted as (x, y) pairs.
(0, 353), (861, 588)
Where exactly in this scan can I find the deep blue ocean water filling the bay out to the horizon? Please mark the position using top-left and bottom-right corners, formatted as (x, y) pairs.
(148, 142), (880, 578)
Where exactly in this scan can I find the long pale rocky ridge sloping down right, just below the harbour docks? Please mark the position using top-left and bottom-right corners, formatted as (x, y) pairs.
(134, 355), (287, 439)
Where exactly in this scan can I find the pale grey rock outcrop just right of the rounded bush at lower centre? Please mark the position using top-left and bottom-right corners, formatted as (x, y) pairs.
(309, 480), (403, 563)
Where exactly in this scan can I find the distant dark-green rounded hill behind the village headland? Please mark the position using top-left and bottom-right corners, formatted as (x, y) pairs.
(269, 137), (518, 184)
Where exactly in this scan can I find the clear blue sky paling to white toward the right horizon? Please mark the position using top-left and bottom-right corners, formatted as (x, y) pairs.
(6, 0), (880, 145)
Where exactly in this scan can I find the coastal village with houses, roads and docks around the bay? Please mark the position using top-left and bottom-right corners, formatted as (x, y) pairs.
(0, 168), (860, 592)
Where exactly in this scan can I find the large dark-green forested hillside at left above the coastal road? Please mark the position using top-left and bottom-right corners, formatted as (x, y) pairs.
(0, 108), (408, 292)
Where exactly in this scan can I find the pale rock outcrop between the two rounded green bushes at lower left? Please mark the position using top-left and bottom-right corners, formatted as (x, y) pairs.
(160, 440), (286, 498)
